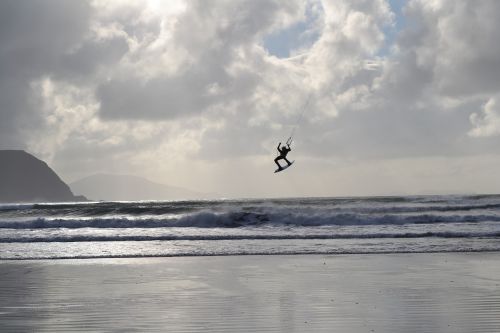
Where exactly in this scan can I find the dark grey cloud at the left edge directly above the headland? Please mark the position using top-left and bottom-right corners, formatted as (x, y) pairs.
(0, 0), (91, 148)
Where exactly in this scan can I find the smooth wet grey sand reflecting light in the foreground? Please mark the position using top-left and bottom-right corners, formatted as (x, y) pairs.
(0, 253), (500, 333)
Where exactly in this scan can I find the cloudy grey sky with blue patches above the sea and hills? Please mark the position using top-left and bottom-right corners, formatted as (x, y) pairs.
(0, 0), (500, 197)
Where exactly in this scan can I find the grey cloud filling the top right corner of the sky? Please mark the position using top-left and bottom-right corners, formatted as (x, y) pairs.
(400, 0), (500, 97)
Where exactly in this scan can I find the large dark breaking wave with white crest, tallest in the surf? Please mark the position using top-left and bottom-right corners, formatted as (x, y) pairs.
(0, 212), (500, 229)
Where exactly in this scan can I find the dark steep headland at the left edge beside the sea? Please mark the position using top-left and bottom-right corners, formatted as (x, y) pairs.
(0, 150), (86, 202)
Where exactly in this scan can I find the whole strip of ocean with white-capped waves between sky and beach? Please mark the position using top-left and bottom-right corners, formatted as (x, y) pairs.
(0, 195), (500, 259)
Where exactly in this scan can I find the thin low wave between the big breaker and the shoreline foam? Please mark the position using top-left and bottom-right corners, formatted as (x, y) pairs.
(0, 231), (500, 243)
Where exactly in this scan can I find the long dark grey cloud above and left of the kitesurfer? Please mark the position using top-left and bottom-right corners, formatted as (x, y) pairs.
(97, 60), (257, 119)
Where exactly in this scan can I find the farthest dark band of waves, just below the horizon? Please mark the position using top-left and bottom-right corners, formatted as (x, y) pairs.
(0, 197), (500, 220)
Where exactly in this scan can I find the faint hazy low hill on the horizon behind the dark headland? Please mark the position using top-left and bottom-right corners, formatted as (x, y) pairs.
(70, 174), (207, 201)
